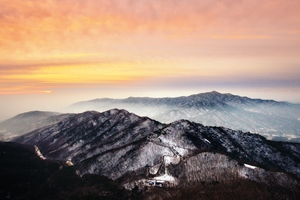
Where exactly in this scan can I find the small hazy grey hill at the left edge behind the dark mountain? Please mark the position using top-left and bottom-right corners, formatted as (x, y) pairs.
(0, 111), (73, 141)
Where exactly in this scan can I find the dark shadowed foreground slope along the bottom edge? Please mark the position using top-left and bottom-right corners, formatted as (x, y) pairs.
(0, 142), (299, 200)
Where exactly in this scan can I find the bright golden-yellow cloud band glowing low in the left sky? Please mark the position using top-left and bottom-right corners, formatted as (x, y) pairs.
(0, 57), (196, 94)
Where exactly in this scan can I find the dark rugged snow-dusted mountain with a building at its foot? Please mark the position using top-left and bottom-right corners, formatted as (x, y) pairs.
(14, 109), (300, 188)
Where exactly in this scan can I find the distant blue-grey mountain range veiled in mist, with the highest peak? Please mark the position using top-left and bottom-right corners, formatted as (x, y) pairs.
(66, 91), (300, 141)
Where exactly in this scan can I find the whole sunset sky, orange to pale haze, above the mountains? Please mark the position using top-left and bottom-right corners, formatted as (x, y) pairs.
(0, 0), (300, 120)
